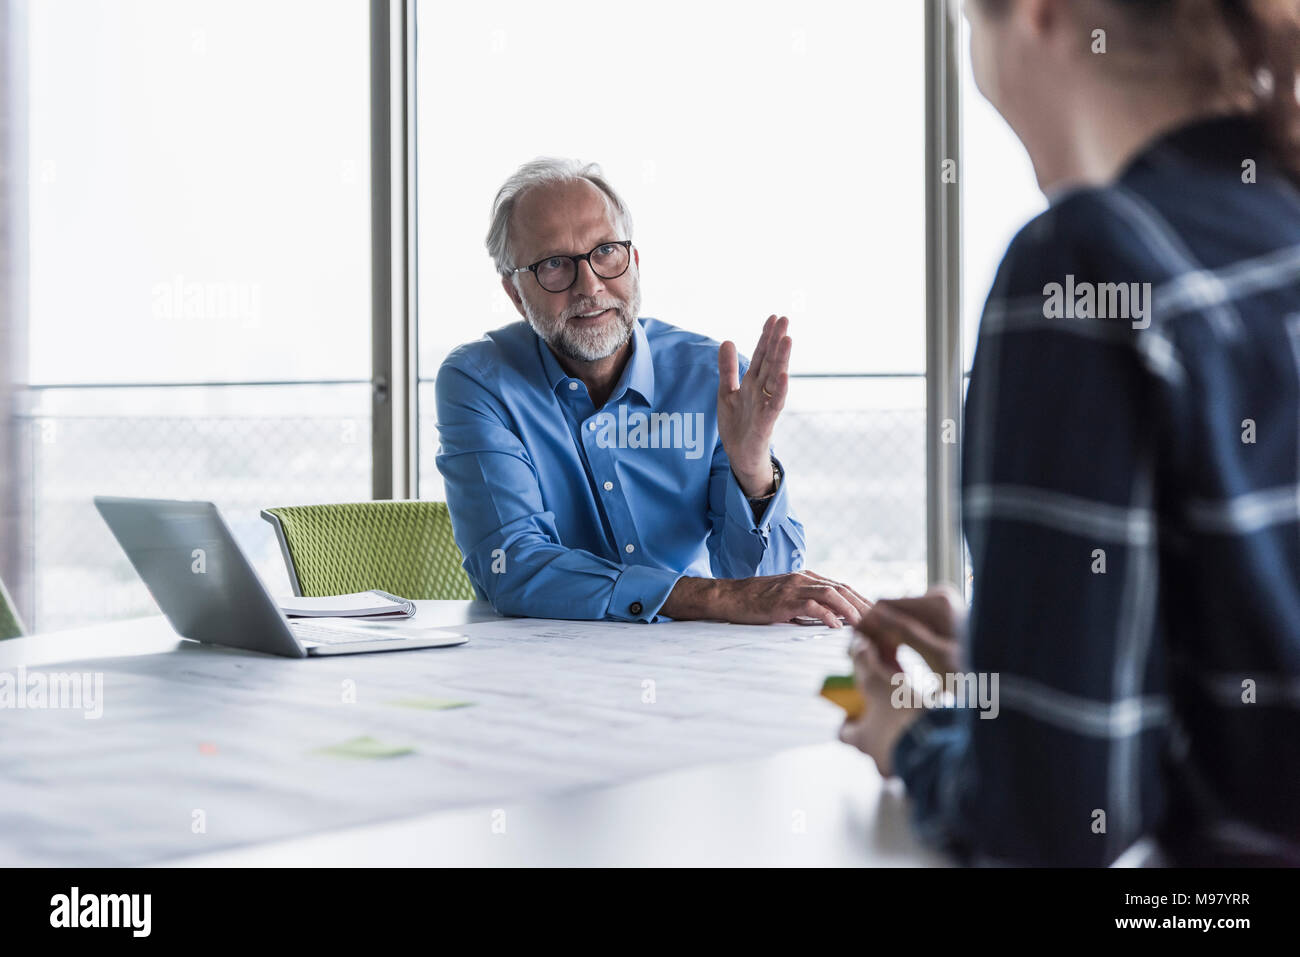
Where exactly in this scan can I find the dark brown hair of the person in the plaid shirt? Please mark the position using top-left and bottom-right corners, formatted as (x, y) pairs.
(979, 0), (1300, 183)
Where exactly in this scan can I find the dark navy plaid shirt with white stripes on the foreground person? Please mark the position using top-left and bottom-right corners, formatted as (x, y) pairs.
(894, 117), (1300, 865)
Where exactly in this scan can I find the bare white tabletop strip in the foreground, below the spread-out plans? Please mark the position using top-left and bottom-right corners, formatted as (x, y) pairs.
(168, 742), (946, 867)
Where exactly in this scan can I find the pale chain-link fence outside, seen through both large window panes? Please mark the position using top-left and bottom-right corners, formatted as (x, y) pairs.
(7, 382), (926, 631)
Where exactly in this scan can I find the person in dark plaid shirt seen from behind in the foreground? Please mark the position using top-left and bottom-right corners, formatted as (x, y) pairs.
(841, 0), (1300, 865)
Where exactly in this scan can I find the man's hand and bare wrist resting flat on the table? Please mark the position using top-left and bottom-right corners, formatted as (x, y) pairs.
(663, 570), (871, 628)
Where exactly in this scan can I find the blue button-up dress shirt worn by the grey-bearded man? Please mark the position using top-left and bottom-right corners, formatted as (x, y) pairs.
(436, 319), (805, 622)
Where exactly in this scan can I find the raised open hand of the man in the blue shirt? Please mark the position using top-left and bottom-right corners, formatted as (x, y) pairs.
(718, 316), (790, 498)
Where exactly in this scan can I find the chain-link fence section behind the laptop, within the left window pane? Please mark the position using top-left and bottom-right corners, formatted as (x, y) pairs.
(16, 386), (371, 631)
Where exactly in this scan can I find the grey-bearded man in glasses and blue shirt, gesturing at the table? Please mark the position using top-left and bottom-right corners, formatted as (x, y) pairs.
(437, 159), (868, 627)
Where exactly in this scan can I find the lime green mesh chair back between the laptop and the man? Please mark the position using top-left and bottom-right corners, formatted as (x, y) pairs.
(261, 502), (477, 598)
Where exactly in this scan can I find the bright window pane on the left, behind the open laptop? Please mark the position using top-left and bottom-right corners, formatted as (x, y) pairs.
(10, 0), (371, 631)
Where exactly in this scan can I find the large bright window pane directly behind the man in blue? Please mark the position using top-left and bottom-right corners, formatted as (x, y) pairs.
(417, 0), (926, 594)
